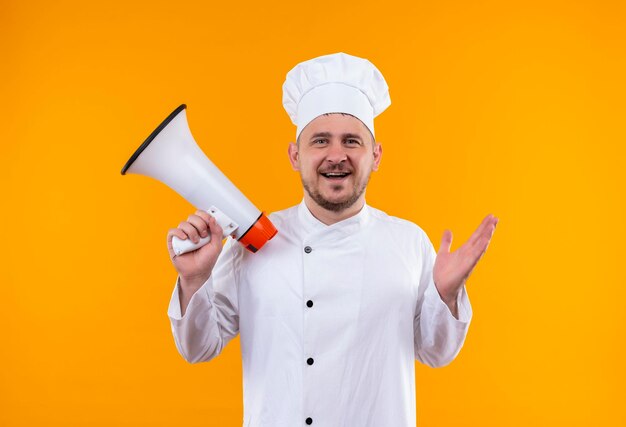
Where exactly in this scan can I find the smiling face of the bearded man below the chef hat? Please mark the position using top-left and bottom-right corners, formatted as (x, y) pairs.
(289, 113), (382, 212)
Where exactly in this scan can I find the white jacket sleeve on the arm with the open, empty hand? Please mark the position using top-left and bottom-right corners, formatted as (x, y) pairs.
(413, 234), (472, 367)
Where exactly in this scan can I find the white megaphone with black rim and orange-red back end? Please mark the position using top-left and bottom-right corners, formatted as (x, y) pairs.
(122, 104), (277, 255)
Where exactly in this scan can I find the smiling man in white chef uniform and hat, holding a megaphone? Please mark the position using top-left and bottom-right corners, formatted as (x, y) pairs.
(168, 53), (497, 427)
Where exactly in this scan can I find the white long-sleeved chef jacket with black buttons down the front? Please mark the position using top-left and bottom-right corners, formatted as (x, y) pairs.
(168, 201), (472, 427)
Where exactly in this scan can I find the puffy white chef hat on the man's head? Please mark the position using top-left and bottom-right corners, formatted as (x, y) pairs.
(283, 53), (391, 138)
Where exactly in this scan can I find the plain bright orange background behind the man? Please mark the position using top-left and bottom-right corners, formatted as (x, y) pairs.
(0, 0), (626, 427)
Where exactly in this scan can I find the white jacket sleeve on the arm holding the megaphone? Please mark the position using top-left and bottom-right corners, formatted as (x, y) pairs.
(167, 238), (243, 363)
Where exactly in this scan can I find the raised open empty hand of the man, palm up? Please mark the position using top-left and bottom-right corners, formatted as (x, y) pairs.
(433, 214), (498, 315)
